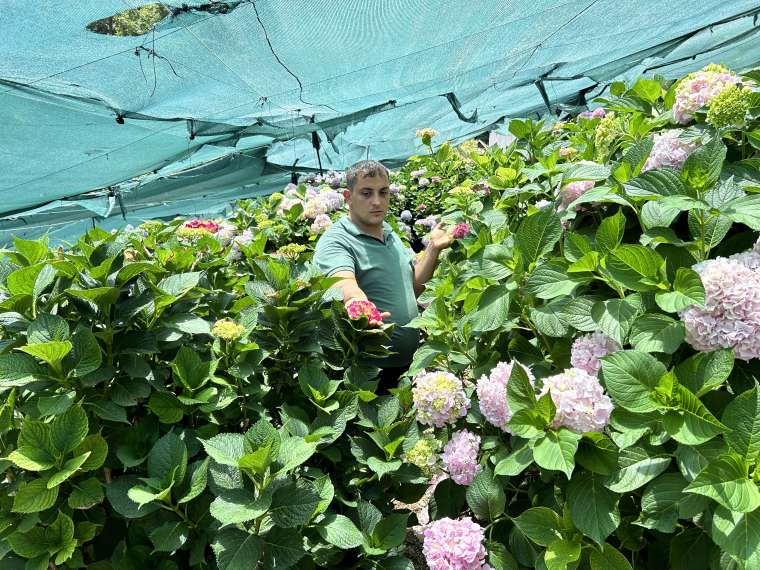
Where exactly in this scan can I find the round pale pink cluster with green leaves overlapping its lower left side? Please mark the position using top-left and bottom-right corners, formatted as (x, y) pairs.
(540, 368), (613, 433)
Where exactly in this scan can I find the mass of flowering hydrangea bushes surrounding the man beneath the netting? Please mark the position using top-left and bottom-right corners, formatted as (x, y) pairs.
(0, 66), (760, 570)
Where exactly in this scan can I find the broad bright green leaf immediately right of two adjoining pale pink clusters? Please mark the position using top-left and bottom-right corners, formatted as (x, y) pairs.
(600, 350), (667, 413)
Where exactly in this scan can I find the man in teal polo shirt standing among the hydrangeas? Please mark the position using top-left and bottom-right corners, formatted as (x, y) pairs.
(314, 160), (452, 390)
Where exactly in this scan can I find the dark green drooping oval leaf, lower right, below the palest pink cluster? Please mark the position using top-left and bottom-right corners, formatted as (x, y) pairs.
(567, 473), (620, 544)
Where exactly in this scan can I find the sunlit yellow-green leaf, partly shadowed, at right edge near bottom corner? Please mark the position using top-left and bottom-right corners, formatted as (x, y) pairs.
(684, 454), (760, 513)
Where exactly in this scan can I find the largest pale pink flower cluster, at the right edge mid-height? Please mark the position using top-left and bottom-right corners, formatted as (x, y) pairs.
(680, 250), (760, 360)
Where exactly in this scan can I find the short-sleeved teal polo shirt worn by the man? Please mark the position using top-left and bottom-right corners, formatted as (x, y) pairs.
(314, 216), (420, 368)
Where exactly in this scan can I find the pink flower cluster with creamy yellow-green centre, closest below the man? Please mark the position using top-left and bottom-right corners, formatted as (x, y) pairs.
(412, 370), (470, 427)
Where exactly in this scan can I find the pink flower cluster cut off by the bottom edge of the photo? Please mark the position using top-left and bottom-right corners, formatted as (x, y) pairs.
(422, 517), (491, 570)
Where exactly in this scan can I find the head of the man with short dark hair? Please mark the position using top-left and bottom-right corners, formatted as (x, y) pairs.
(345, 160), (390, 227)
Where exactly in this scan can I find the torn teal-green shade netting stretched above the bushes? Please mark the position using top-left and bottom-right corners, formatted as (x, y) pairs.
(0, 0), (760, 241)
